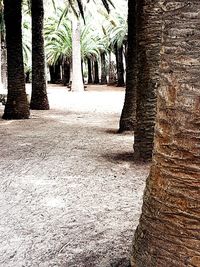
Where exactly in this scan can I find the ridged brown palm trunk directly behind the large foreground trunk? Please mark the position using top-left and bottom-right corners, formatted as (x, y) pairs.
(134, 0), (162, 160)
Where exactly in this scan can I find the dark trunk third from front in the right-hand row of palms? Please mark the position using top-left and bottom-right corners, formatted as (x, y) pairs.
(119, 0), (137, 133)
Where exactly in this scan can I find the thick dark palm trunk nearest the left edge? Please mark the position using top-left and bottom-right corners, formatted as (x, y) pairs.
(3, 0), (29, 119)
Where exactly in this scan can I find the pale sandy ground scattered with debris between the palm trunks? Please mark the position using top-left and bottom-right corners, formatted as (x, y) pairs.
(0, 86), (148, 267)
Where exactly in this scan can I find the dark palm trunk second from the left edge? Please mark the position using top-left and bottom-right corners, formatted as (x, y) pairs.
(30, 0), (49, 110)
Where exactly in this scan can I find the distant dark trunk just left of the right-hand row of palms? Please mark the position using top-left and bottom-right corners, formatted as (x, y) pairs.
(116, 46), (125, 87)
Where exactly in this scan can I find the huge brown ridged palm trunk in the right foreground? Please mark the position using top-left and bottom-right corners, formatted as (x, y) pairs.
(132, 0), (200, 267)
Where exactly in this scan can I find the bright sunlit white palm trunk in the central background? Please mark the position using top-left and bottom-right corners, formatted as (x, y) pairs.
(71, 16), (84, 92)
